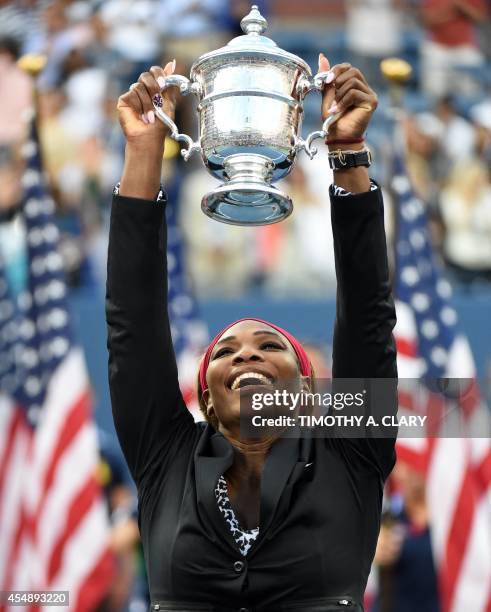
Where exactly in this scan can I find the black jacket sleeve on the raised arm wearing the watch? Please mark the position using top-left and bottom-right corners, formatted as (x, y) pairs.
(330, 187), (397, 479)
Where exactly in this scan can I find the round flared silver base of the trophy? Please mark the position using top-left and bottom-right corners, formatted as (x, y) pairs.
(201, 154), (293, 226)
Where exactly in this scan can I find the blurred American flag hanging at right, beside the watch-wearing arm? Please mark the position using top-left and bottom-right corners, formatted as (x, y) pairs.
(392, 160), (491, 612)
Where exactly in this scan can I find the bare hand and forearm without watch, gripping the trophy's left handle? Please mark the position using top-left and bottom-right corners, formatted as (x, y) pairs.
(117, 60), (177, 200)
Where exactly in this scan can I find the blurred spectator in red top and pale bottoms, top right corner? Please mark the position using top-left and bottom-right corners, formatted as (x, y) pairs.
(421, 0), (486, 98)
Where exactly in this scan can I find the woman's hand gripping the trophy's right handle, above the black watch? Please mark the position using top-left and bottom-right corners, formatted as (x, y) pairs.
(319, 53), (378, 140)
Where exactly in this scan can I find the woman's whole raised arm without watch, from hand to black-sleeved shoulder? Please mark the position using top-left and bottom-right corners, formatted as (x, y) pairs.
(106, 63), (194, 485)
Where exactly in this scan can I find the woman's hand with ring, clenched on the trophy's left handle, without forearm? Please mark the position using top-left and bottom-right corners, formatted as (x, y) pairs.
(117, 60), (177, 152)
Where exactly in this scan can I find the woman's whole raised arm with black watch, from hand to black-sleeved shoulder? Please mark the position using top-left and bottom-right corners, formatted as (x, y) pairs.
(319, 57), (397, 478)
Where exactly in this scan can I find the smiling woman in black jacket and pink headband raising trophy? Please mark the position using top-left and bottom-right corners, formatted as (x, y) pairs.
(107, 55), (397, 612)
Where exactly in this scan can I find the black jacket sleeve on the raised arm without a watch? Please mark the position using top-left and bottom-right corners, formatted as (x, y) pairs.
(106, 196), (194, 486)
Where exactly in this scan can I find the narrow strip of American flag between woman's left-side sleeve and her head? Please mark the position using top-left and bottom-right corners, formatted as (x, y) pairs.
(166, 184), (208, 421)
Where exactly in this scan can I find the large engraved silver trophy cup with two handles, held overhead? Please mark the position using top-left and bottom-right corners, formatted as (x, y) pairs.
(155, 6), (341, 225)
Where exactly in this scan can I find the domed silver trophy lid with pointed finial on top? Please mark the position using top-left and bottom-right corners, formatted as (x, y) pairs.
(191, 4), (312, 74)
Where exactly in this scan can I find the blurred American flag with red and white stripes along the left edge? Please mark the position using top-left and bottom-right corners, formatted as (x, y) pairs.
(0, 121), (113, 612)
